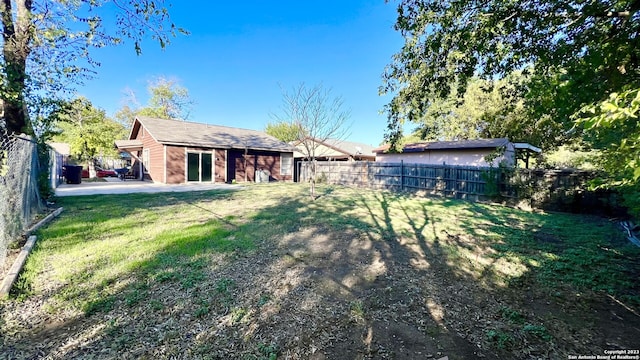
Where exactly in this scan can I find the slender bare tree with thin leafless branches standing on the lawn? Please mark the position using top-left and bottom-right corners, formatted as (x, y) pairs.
(275, 83), (351, 199)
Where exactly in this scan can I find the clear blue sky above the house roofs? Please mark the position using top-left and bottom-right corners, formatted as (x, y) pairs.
(78, 0), (402, 145)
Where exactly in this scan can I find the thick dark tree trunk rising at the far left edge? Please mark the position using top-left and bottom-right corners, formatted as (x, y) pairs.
(0, 0), (33, 134)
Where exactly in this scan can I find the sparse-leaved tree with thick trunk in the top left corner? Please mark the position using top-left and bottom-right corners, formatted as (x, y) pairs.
(0, 0), (186, 133)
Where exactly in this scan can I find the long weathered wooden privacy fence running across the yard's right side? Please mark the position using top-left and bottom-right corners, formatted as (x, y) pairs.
(297, 161), (624, 216)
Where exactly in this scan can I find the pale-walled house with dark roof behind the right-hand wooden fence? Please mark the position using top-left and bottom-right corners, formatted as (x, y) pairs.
(374, 138), (541, 166)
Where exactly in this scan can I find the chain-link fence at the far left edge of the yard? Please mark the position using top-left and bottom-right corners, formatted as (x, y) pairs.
(0, 130), (43, 267)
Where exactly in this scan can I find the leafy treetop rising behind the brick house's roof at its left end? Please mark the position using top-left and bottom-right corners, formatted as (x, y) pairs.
(115, 77), (193, 126)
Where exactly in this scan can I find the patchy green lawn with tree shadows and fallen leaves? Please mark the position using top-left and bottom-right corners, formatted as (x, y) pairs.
(0, 184), (640, 359)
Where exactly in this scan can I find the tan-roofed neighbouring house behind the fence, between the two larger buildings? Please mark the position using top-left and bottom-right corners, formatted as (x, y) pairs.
(291, 137), (376, 181)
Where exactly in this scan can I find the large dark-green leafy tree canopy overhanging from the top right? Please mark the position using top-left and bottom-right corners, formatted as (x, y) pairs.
(381, 0), (640, 148)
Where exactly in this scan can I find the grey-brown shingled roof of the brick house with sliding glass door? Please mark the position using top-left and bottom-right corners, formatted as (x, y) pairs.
(129, 116), (294, 152)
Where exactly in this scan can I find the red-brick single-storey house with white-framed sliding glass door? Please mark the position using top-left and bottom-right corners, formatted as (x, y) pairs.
(116, 117), (294, 184)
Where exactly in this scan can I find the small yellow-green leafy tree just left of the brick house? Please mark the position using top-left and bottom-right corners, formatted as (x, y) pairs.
(54, 97), (126, 177)
